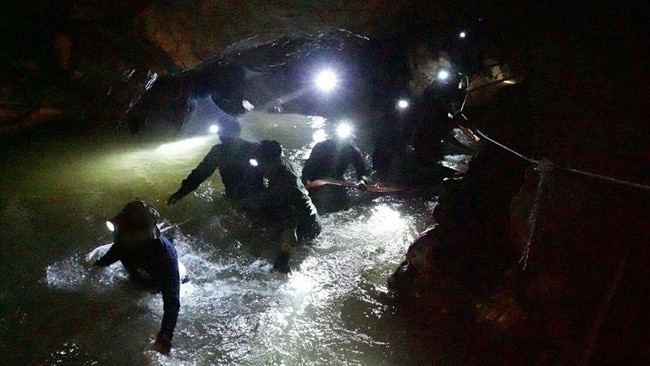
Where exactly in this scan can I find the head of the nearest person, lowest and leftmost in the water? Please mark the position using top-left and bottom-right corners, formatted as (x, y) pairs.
(111, 199), (160, 249)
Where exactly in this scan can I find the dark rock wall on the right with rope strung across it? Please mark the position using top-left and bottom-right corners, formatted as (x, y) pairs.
(389, 2), (650, 365)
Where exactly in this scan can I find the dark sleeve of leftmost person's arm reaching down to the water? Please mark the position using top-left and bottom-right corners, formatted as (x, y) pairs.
(158, 238), (181, 344)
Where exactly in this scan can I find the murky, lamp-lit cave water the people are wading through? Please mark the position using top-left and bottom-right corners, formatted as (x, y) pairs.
(0, 115), (435, 365)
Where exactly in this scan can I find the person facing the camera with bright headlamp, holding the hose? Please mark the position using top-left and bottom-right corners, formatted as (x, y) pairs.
(302, 125), (369, 214)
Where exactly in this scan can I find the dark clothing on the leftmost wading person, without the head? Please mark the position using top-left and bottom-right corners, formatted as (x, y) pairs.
(95, 236), (180, 344)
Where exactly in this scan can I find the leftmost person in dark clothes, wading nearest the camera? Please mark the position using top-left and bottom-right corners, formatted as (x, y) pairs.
(95, 200), (181, 354)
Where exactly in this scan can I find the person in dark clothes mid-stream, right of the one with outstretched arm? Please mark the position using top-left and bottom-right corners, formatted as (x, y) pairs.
(249, 140), (321, 272)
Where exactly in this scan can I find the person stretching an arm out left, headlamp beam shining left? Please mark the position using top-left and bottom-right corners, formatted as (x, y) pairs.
(167, 119), (264, 206)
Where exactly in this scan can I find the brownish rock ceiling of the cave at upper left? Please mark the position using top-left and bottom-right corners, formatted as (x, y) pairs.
(0, 0), (456, 133)
